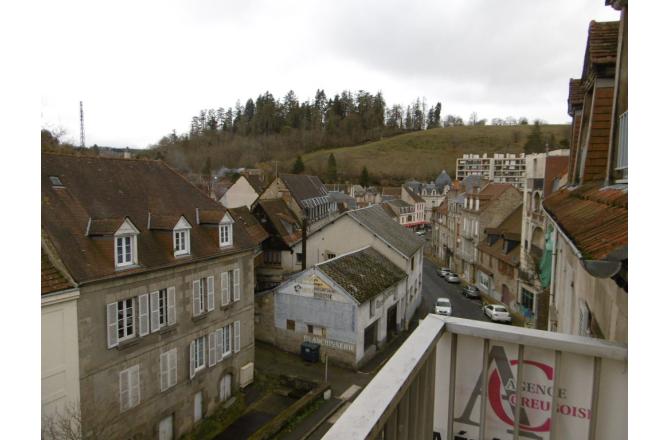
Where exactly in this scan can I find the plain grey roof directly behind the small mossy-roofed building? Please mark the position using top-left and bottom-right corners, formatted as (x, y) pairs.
(346, 205), (424, 258)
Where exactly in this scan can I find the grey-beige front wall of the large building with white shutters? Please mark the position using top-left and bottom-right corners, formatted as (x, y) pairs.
(78, 252), (254, 438)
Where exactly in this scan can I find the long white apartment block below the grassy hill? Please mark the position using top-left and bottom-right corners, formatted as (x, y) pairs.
(456, 153), (526, 190)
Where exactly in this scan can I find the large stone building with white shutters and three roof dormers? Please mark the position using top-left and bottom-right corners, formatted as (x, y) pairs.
(41, 154), (257, 439)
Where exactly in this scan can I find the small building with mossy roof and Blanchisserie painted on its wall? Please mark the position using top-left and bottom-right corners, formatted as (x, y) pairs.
(272, 246), (407, 368)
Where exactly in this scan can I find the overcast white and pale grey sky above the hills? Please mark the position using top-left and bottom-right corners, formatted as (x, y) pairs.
(40, 0), (619, 148)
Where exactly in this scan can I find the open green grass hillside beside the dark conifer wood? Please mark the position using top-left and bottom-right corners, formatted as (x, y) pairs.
(298, 125), (570, 184)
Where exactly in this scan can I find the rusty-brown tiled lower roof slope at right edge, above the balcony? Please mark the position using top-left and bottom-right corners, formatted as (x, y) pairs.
(543, 184), (628, 260)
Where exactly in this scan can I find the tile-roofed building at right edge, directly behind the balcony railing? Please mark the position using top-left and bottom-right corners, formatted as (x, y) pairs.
(541, 0), (628, 343)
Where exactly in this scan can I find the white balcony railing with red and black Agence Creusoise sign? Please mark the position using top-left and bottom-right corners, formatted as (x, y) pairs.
(323, 315), (628, 440)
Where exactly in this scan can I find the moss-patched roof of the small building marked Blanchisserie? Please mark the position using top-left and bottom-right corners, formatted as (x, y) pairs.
(316, 247), (407, 304)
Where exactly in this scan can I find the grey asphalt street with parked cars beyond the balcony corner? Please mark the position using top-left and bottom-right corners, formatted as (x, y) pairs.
(419, 258), (487, 321)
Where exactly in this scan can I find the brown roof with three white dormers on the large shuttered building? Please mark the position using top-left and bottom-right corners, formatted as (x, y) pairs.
(41, 153), (253, 284)
